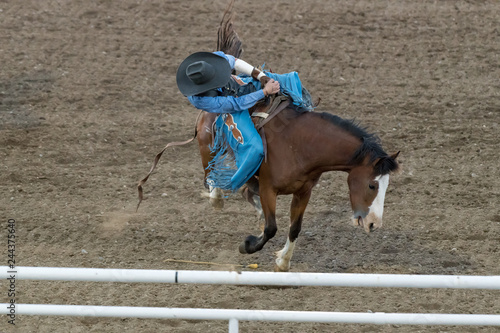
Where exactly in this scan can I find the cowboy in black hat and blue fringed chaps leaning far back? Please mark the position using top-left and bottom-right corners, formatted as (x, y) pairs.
(177, 51), (280, 191)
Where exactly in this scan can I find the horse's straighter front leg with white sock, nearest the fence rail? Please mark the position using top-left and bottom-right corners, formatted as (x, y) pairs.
(275, 190), (311, 272)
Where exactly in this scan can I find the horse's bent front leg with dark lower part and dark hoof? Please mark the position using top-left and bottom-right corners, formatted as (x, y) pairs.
(240, 183), (278, 253)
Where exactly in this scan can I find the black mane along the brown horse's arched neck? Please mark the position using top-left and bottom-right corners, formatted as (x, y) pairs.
(321, 113), (399, 175)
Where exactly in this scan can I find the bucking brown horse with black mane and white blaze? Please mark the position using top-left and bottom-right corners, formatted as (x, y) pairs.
(197, 104), (399, 271)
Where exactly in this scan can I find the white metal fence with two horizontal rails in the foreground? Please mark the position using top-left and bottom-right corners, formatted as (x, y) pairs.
(0, 266), (500, 333)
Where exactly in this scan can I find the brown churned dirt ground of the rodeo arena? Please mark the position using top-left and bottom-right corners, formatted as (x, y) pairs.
(0, 0), (500, 332)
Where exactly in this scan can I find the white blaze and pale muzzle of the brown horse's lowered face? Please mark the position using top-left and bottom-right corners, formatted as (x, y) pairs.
(351, 174), (389, 232)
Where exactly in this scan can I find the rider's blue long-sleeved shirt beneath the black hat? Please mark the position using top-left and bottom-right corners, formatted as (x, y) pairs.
(188, 51), (265, 113)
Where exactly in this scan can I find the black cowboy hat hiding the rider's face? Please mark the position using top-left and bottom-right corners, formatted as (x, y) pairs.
(177, 52), (231, 96)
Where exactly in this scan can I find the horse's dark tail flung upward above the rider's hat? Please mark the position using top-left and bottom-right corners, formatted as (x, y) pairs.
(217, 0), (243, 58)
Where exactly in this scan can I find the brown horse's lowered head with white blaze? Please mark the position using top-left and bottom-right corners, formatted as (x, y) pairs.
(347, 152), (399, 232)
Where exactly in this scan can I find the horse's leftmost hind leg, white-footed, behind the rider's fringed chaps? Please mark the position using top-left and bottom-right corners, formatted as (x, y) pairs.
(196, 112), (224, 209)
